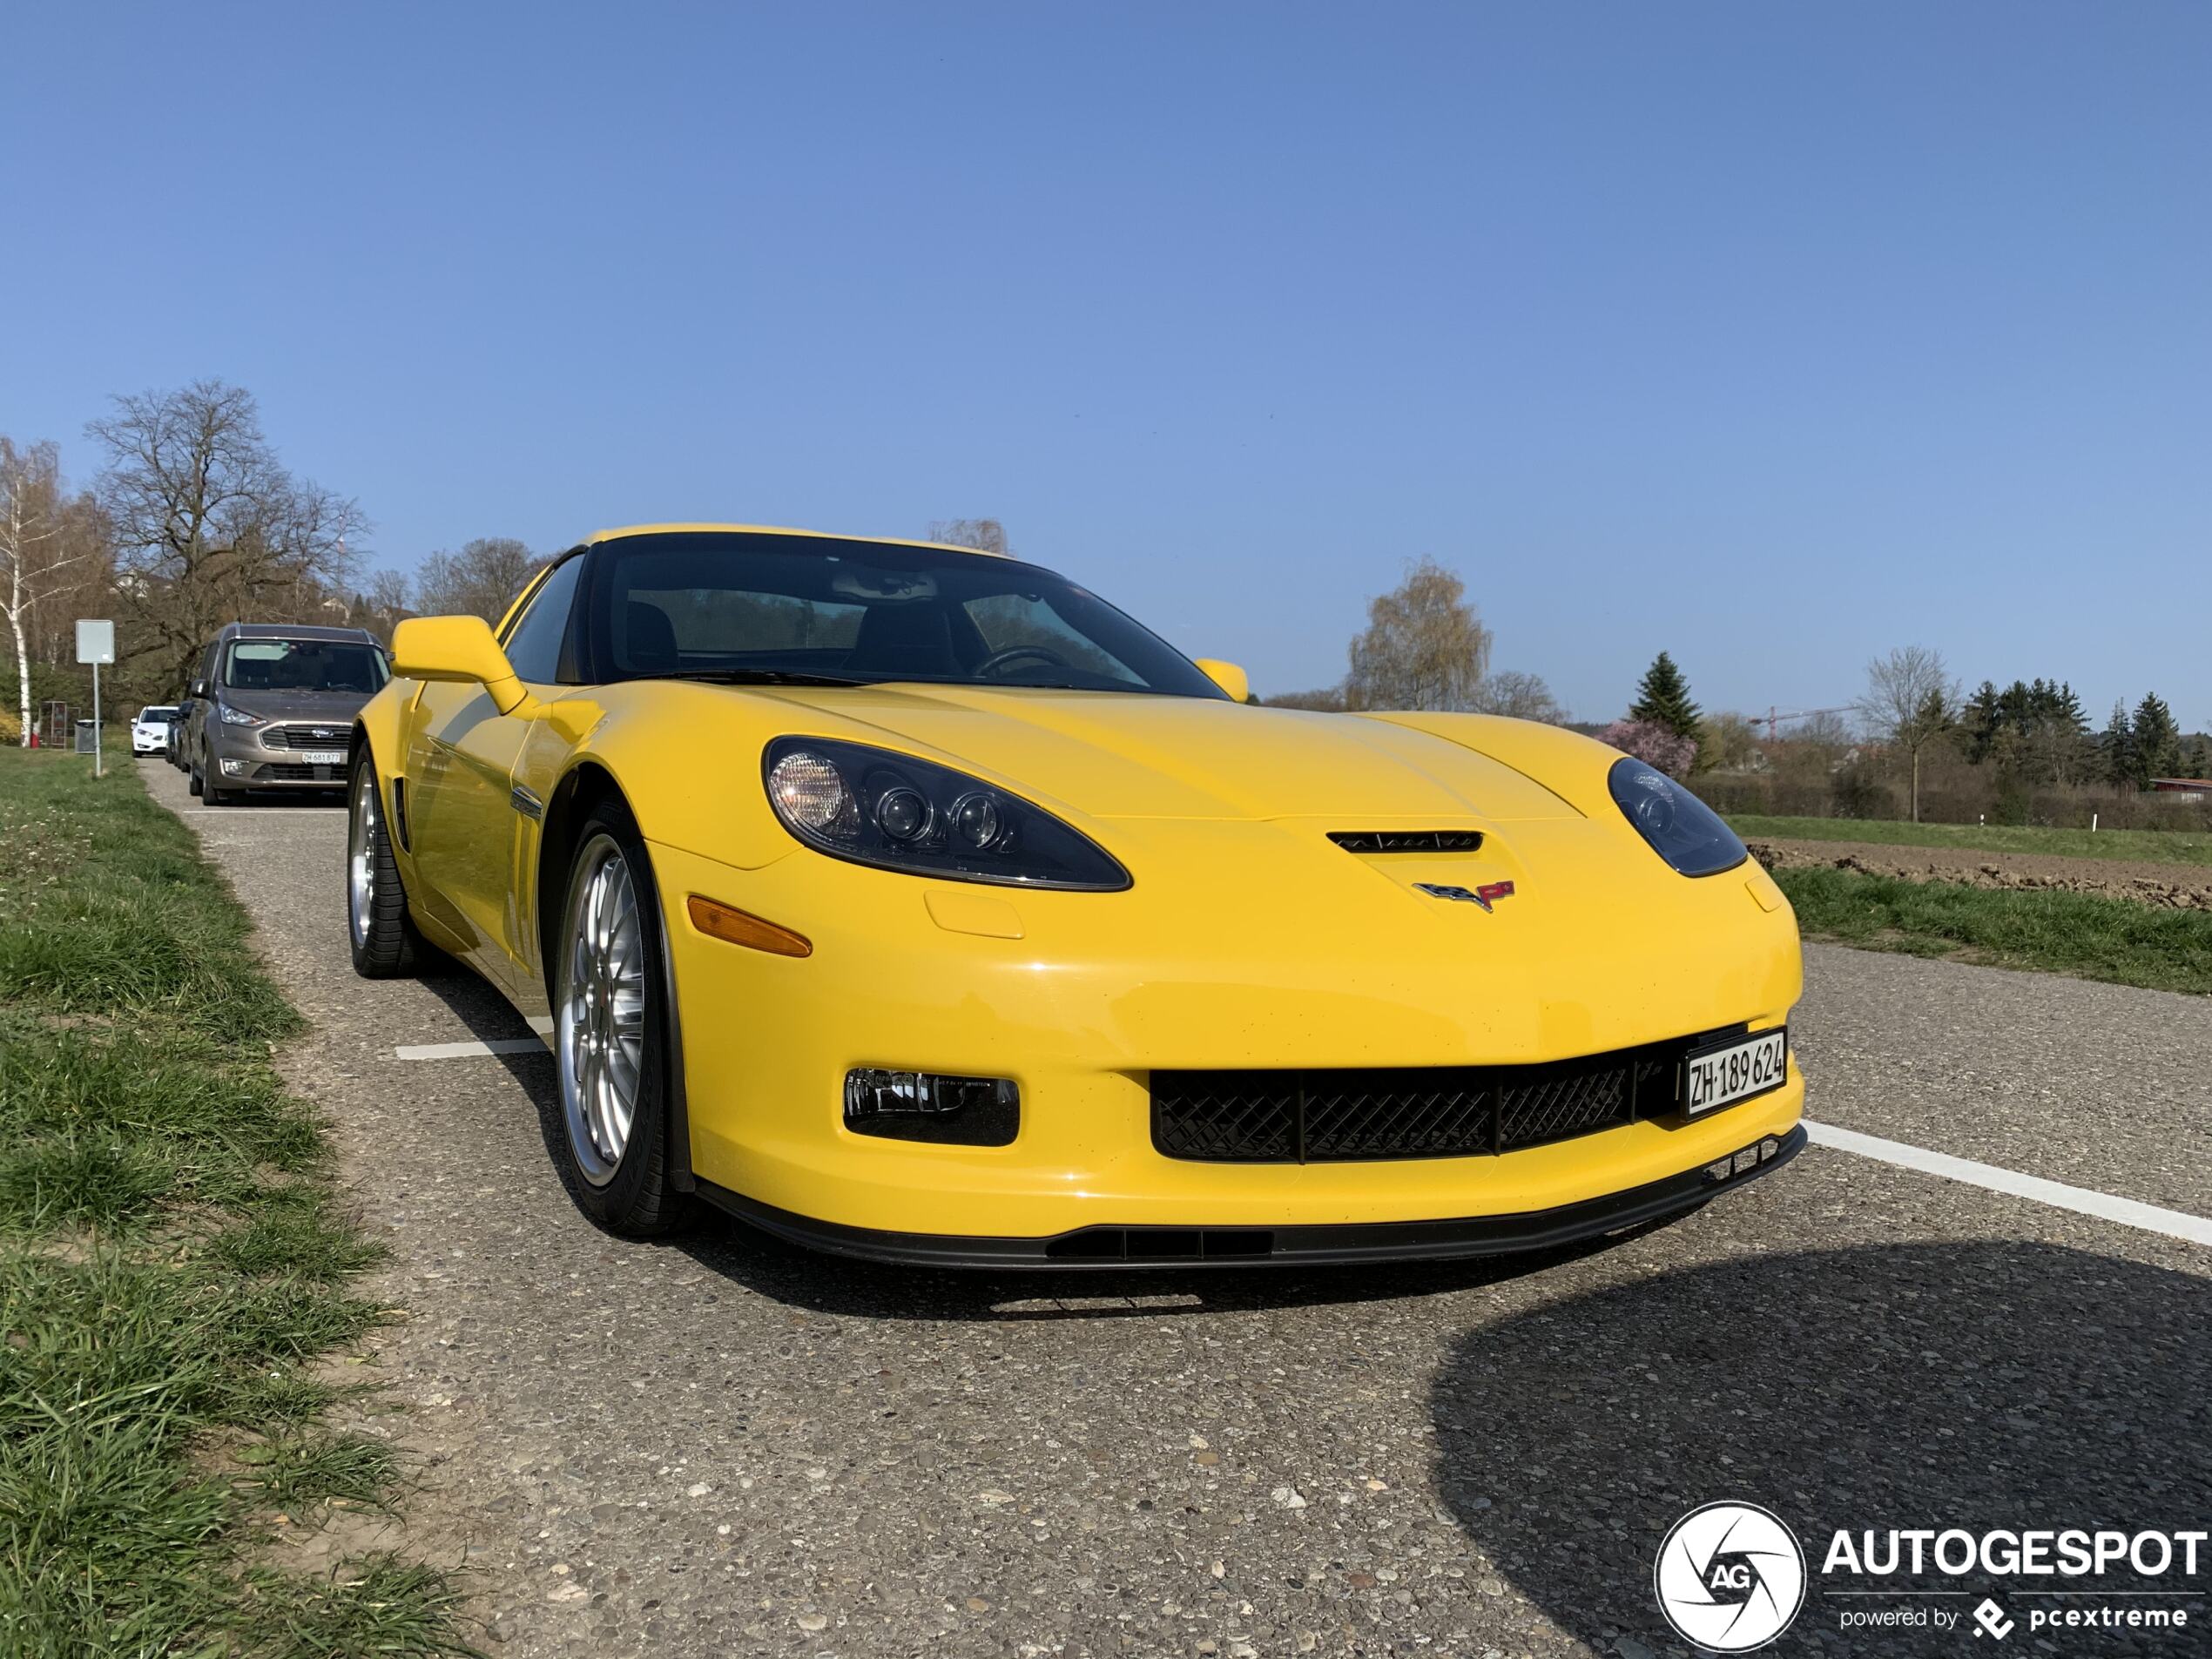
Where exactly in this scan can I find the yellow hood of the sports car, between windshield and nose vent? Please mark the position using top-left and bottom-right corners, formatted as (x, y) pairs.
(745, 685), (1581, 825)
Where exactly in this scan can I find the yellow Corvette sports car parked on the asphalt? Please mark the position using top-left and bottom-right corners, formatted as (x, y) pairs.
(347, 524), (1805, 1267)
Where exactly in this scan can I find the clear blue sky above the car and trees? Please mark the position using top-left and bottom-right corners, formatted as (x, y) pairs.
(0, 3), (2212, 728)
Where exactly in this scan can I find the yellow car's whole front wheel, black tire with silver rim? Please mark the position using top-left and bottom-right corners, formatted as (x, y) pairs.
(546, 800), (692, 1238)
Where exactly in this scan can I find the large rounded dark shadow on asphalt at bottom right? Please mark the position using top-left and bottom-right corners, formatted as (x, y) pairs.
(1431, 1241), (2212, 1655)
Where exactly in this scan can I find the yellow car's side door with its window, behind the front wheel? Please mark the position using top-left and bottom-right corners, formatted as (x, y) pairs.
(407, 553), (584, 993)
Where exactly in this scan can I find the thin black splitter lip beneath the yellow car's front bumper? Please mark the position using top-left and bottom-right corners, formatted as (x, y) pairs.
(699, 1128), (1805, 1272)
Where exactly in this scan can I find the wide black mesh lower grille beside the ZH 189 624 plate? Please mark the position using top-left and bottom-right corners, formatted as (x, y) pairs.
(1152, 1027), (1743, 1163)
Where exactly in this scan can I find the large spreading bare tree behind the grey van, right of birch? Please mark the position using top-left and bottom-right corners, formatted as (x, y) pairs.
(86, 381), (365, 684)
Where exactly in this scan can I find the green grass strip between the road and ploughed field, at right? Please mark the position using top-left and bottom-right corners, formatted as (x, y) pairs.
(1774, 869), (2212, 995)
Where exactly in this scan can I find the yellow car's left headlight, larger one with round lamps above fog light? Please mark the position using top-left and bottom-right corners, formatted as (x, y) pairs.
(761, 737), (1130, 894)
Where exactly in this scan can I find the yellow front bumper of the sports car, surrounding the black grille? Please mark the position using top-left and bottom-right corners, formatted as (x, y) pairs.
(652, 823), (1805, 1265)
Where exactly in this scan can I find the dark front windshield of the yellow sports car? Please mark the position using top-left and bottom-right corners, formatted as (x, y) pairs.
(593, 533), (1221, 697)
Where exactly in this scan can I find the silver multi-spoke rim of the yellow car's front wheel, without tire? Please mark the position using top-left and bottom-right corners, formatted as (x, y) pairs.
(557, 836), (646, 1185)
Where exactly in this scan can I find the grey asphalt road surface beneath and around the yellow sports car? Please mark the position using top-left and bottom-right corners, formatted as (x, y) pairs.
(144, 765), (2212, 1659)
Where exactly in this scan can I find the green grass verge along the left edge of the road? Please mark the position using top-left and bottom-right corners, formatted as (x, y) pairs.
(0, 750), (469, 1659)
